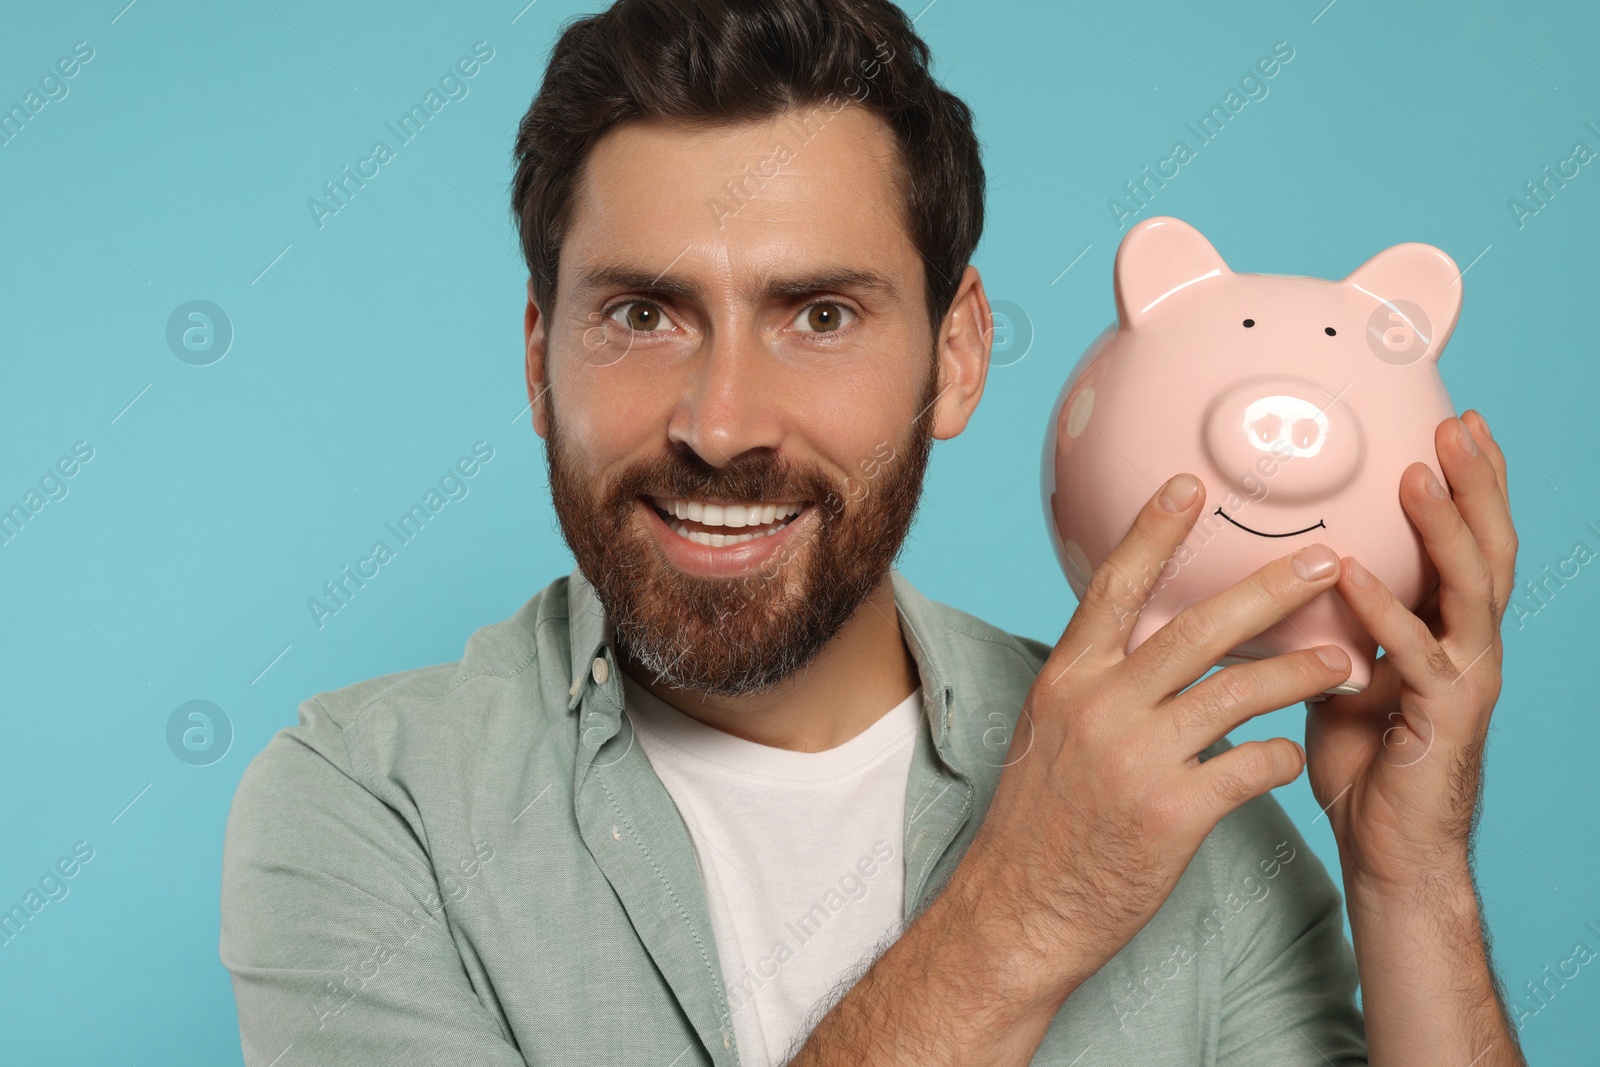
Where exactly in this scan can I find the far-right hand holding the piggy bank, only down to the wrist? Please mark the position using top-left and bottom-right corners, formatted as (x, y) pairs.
(1306, 411), (1517, 894)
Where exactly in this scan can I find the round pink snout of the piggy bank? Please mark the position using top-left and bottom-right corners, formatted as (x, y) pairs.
(1205, 378), (1362, 502)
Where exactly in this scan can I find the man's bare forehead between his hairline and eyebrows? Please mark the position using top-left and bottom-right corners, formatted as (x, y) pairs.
(562, 107), (917, 296)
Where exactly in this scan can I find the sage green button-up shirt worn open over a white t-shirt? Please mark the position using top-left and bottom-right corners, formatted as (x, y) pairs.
(219, 571), (1366, 1067)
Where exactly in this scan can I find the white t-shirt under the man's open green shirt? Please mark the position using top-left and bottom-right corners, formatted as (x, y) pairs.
(622, 672), (923, 1067)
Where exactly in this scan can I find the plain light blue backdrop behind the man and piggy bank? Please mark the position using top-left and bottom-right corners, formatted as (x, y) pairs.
(0, 0), (1600, 1067)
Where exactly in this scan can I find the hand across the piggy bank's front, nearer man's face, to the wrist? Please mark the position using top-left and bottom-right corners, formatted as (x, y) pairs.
(952, 474), (1350, 1000)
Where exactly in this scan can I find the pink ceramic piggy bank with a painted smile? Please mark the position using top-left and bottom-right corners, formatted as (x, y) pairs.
(1042, 218), (1461, 694)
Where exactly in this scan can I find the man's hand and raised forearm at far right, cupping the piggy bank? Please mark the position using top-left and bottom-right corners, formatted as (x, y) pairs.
(1306, 411), (1526, 1067)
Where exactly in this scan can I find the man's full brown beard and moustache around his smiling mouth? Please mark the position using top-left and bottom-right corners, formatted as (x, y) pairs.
(544, 373), (938, 697)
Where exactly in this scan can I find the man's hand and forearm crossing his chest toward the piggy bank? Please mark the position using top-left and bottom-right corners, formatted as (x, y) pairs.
(789, 474), (1350, 1067)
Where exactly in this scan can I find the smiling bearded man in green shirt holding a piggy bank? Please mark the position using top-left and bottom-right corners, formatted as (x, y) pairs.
(221, 0), (1522, 1067)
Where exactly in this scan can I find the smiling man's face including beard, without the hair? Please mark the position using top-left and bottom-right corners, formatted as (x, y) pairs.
(530, 107), (976, 696)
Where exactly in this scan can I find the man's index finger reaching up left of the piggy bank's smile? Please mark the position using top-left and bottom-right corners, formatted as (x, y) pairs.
(1045, 474), (1205, 677)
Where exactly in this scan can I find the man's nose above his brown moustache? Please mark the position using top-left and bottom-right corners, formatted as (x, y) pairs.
(667, 330), (786, 467)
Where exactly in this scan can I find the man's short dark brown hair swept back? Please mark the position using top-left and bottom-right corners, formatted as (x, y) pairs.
(510, 0), (984, 338)
